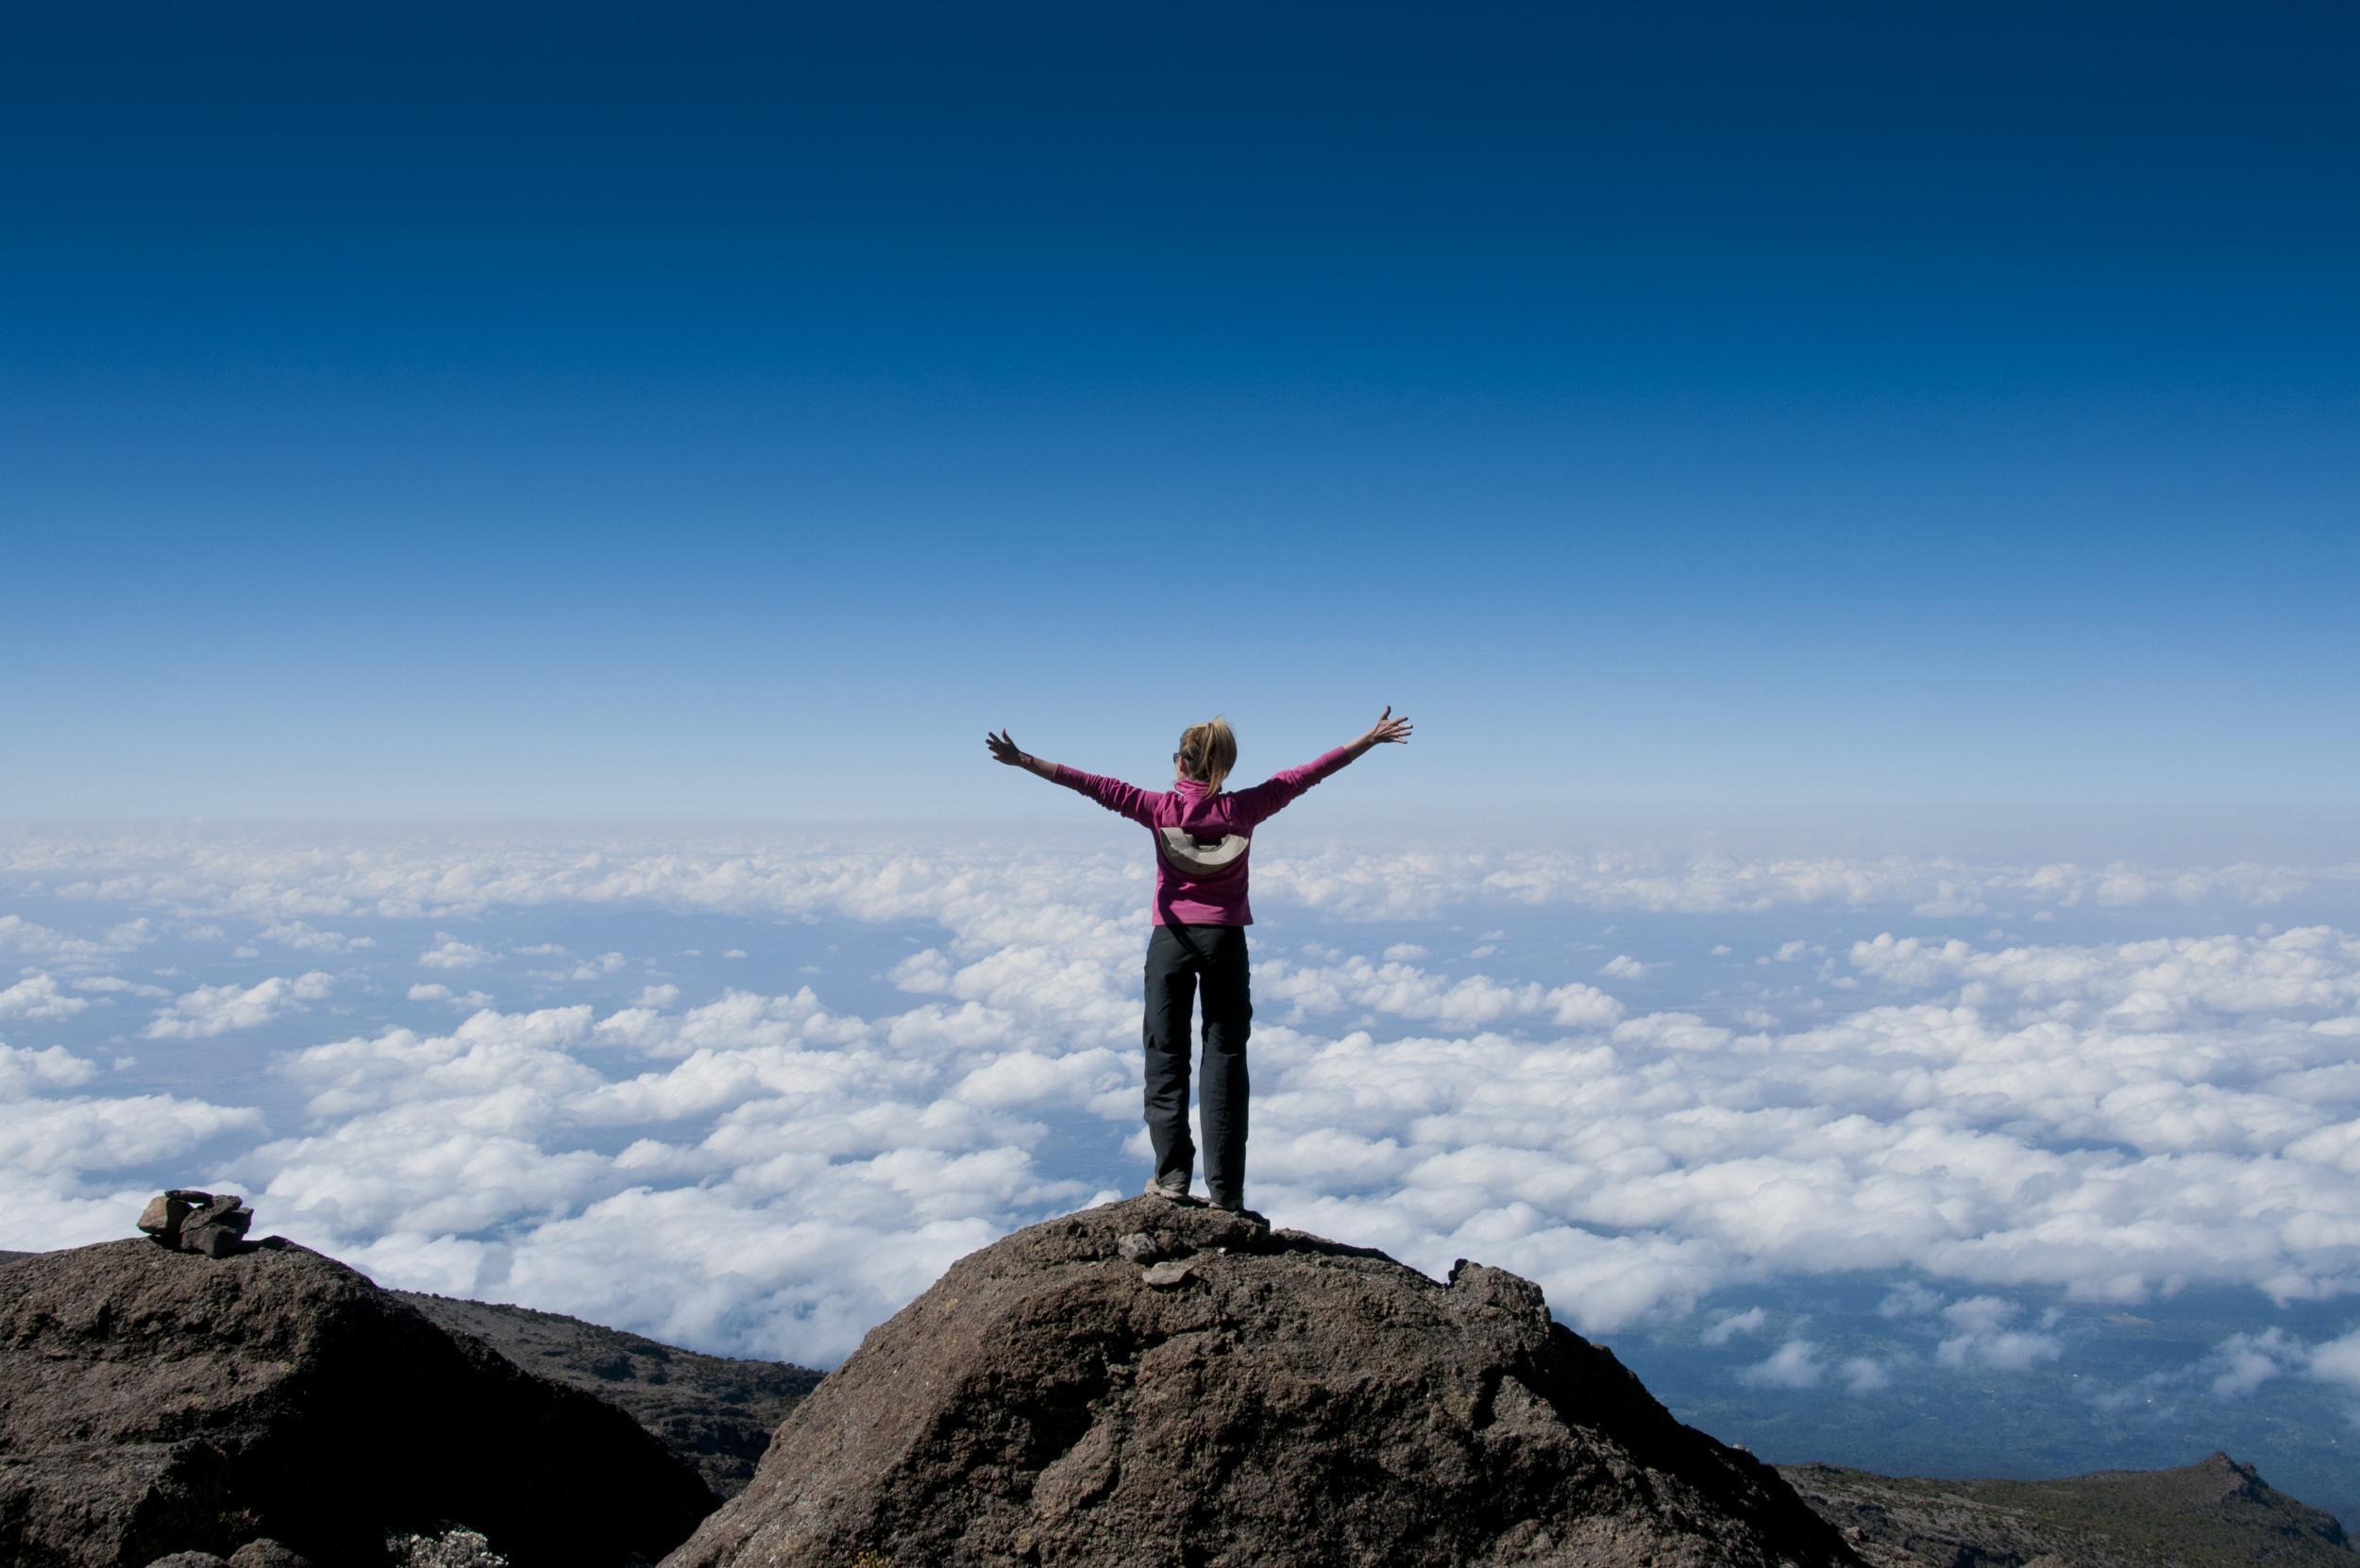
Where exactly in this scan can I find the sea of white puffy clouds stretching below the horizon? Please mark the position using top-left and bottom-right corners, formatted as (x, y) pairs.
(0, 827), (2360, 1492)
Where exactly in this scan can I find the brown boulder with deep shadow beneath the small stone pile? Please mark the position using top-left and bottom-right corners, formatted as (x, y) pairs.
(0, 1238), (716, 1568)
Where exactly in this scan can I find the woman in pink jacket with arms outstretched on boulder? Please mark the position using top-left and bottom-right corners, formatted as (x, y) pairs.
(985, 706), (1409, 1211)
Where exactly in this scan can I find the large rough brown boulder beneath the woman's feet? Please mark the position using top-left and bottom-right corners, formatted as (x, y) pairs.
(666, 1197), (1858, 1568)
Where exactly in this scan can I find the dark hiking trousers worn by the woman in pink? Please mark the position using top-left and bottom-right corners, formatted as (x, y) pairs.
(1145, 926), (1254, 1209)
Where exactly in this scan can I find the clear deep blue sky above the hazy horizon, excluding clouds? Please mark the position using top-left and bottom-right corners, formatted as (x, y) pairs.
(0, 5), (2360, 818)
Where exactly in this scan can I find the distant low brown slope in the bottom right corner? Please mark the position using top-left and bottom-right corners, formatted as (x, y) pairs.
(1779, 1455), (2360, 1568)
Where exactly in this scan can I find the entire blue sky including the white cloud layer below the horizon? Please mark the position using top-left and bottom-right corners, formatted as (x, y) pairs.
(0, 5), (2360, 1518)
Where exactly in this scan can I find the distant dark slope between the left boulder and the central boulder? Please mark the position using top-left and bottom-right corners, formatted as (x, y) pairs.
(392, 1290), (821, 1497)
